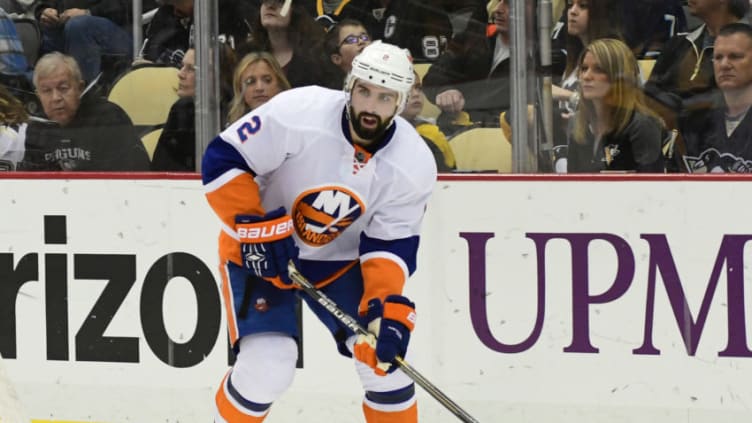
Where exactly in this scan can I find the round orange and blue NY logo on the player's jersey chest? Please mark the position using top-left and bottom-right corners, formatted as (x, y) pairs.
(292, 186), (365, 247)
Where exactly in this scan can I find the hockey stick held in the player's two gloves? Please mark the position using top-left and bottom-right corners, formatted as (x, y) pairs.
(287, 260), (478, 423)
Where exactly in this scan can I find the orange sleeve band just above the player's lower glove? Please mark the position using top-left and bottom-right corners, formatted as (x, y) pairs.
(358, 257), (405, 310)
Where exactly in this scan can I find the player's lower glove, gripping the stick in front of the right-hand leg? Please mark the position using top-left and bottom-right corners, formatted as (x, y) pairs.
(354, 295), (415, 376)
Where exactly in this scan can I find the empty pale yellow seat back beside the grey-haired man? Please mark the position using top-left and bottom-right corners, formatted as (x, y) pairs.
(107, 66), (178, 135)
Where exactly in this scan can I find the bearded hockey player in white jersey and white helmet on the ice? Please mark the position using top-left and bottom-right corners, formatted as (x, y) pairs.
(202, 41), (436, 423)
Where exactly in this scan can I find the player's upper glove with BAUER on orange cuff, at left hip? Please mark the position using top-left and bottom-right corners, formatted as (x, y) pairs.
(235, 207), (299, 289)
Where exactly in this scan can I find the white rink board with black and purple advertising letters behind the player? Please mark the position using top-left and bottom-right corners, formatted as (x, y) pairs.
(0, 175), (752, 423)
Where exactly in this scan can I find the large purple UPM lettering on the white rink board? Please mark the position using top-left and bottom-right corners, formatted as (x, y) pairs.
(460, 232), (752, 357)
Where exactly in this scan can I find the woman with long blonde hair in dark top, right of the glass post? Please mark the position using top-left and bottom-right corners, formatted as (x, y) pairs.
(567, 38), (665, 173)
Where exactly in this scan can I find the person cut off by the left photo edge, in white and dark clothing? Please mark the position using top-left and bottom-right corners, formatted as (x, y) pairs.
(0, 84), (29, 171)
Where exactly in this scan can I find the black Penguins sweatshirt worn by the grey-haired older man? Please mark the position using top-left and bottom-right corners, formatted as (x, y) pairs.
(19, 93), (149, 171)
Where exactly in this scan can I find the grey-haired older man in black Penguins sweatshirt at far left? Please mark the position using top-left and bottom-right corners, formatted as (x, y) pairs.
(19, 52), (149, 171)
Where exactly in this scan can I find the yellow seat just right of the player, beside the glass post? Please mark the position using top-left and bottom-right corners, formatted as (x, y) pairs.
(449, 128), (512, 173)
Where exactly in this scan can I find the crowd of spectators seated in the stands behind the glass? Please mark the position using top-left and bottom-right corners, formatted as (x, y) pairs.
(0, 0), (752, 173)
